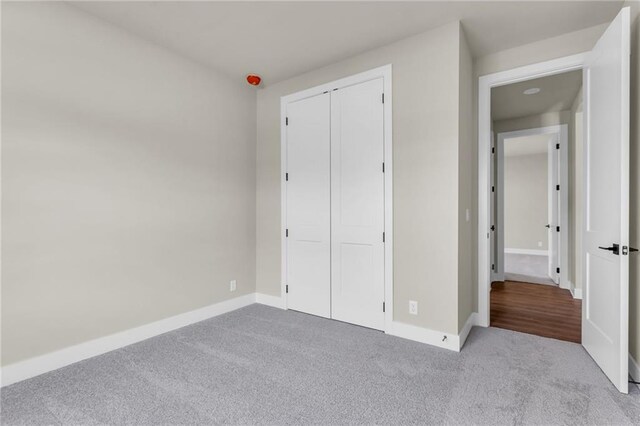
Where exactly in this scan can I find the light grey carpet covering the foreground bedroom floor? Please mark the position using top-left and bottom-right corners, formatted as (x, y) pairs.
(2, 305), (640, 425)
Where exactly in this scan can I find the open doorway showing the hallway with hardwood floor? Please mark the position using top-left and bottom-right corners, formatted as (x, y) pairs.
(490, 69), (582, 343)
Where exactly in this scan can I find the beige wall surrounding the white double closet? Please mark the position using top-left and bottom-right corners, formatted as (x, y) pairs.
(256, 23), (470, 334)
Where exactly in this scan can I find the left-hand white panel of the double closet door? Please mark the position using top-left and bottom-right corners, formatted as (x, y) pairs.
(286, 93), (331, 318)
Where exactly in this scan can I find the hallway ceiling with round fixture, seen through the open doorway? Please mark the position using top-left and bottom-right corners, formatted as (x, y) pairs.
(491, 70), (582, 121)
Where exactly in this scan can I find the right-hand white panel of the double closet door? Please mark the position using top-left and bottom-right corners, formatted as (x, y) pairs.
(331, 78), (384, 330)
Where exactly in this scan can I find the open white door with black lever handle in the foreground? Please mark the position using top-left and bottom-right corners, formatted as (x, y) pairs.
(582, 8), (630, 393)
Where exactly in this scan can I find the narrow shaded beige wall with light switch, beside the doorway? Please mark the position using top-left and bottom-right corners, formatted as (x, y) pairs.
(458, 27), (477, 332)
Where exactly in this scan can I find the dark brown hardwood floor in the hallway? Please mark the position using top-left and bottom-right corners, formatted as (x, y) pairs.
(491, 281), (582, 343)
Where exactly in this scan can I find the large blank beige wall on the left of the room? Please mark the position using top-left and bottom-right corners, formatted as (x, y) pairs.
(2, 3), (256, 365)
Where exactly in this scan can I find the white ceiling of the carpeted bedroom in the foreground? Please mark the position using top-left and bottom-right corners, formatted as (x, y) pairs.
(70, 0), (623, 84)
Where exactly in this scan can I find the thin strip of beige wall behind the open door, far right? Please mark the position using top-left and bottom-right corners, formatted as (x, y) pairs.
(625, 1), (640, 366)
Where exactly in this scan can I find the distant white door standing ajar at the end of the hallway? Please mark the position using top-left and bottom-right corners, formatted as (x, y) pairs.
(547, 134), (560, 284)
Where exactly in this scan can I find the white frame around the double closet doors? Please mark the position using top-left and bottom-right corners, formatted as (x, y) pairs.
(280, 64), (393, 333)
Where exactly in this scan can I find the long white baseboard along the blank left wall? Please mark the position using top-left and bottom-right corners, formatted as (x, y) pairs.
(0, 293), (256, 387)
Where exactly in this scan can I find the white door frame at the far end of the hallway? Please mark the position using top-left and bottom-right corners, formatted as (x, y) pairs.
(492, 124), (571, 290)
